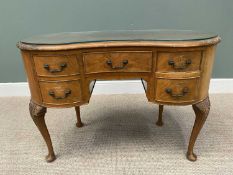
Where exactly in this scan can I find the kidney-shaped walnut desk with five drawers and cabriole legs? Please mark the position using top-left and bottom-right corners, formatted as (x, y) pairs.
(17, 30), (220, 162)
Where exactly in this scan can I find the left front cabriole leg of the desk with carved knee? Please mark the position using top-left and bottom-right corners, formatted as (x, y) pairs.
(29, 101), (56, 162)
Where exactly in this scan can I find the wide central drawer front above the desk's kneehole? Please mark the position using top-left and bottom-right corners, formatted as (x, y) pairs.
(83, 51), (152, 73)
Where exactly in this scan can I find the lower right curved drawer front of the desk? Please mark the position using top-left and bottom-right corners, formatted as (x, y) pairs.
(156, 78), (199, 103)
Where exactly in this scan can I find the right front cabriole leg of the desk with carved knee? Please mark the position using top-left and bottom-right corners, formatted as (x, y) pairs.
(187, 97), (210, 161)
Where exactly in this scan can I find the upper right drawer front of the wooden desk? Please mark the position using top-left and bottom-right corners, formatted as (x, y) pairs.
(157, 51), (202, 72)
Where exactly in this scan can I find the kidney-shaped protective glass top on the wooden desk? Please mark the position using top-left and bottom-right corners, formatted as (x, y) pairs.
(21, 30), (217, 45)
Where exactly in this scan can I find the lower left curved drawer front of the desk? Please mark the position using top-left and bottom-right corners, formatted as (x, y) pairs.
(40, 80), (81, 105)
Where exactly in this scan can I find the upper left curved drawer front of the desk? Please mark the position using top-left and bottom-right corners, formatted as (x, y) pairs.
(33, 55), (80, 77)
